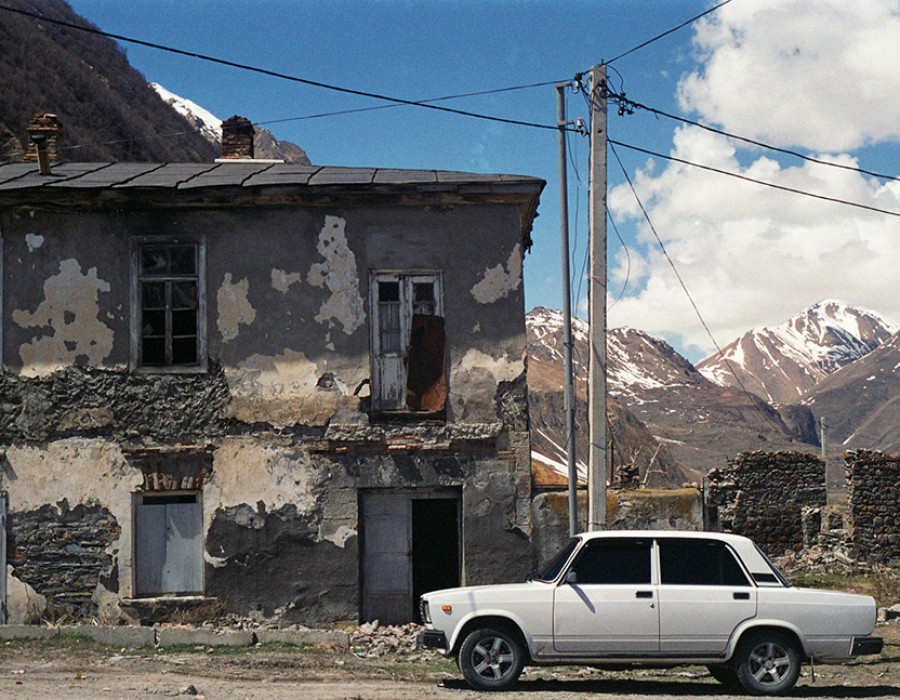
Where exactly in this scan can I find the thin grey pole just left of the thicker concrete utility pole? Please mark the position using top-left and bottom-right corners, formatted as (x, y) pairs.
(556, 83), (578, 537)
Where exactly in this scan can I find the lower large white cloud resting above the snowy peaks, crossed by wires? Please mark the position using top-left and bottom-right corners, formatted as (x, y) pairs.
(609, 128), (900, 359)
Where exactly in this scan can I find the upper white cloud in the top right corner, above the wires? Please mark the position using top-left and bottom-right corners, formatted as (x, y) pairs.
(679, 0), (900, 151)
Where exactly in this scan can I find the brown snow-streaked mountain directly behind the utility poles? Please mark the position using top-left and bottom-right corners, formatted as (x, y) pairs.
(526, 307), (815, 486)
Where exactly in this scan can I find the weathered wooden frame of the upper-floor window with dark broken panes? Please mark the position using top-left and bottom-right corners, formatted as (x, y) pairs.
(130, 236), (209, 374)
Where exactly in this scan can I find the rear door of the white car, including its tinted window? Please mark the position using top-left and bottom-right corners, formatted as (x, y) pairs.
(657, 538), (757, 656)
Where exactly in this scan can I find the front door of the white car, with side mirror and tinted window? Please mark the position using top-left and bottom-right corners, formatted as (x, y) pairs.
(553, 538), (659, 657)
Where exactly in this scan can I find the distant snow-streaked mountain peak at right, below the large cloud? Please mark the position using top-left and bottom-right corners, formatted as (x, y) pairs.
(697, 300), (898, 405)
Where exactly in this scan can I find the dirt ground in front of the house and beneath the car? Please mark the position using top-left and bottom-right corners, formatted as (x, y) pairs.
(0, 620), (900, 700)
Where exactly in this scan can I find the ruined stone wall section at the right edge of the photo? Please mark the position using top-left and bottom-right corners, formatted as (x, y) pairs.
(844, 450), (900, 566)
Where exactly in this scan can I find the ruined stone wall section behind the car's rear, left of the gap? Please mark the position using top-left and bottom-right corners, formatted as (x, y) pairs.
(707, 452), (826, 556)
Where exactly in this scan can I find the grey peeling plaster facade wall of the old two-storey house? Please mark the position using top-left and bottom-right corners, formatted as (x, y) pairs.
(0, 200), (533, 622)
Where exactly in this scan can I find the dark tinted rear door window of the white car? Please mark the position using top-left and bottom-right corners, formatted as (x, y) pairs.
(659, 539), (750, 586)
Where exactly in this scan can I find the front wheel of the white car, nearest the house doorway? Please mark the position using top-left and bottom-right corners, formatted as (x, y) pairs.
(459, 627), (525, 690)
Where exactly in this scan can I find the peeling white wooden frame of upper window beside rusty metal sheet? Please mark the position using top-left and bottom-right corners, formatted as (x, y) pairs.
(369, 269), (445, 415)
